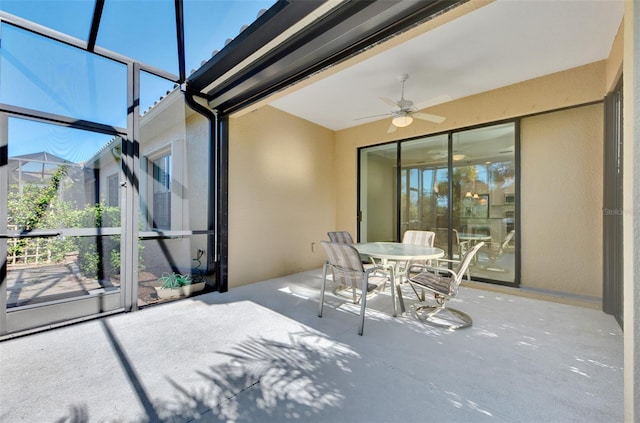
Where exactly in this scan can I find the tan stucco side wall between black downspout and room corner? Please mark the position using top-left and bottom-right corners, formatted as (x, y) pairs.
(229, 106), (336, 288)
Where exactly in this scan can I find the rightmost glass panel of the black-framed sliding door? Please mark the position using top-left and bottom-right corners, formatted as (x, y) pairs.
(452, 123), (516, 283)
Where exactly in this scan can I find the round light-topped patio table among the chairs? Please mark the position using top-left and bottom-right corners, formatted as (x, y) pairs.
(353, 242), (444, 317)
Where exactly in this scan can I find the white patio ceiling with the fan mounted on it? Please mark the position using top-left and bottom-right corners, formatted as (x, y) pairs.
(270, 0), (624, 130)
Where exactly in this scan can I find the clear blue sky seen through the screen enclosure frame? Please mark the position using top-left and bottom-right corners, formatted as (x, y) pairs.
(0, 0), (275, 162)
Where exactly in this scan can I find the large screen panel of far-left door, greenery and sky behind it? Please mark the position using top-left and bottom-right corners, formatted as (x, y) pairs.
(0, 115), (122, 332)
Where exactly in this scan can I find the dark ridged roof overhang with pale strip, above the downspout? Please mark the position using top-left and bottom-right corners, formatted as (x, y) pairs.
(187, 0), (466, 115)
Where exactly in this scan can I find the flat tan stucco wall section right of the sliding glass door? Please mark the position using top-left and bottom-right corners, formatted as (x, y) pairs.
(520, 104), (604, 297)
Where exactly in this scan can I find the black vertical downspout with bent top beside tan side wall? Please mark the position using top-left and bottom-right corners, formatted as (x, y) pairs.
(183, 89), (229, 292)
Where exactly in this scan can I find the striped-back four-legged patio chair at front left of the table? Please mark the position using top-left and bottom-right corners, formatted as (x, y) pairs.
(318, 241), (395, 335)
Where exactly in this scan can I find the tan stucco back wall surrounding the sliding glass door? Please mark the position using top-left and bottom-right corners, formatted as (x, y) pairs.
(335, 61), (607, 297)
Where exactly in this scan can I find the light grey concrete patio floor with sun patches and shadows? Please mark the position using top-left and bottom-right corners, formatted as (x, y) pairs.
(0, 269), (623, 423)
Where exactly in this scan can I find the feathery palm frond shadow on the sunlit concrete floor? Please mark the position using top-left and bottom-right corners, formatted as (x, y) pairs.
(156, 332), (358, 422)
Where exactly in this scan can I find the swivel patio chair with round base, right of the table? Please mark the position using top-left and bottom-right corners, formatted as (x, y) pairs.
(406, 242), (484, 330)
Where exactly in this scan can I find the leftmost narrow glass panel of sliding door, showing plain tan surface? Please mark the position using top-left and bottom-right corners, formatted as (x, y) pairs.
(358, 143), (398, 242)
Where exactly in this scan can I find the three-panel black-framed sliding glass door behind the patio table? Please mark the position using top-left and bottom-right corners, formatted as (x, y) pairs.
(359, 122), (518, 284)
